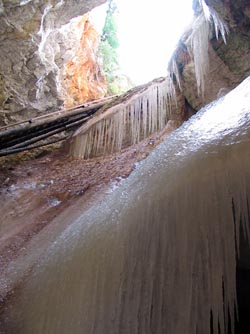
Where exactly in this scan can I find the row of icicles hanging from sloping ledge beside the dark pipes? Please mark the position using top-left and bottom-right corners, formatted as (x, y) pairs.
(70, 77), (176, 159)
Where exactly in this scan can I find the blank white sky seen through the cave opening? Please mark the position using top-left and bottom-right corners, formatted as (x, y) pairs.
(92, 0), (193, 84)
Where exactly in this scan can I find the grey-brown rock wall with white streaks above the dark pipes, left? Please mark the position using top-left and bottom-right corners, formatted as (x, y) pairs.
(0, 0), (105, 124)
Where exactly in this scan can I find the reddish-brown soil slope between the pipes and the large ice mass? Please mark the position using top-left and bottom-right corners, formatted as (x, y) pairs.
(0, 122), (179, 298)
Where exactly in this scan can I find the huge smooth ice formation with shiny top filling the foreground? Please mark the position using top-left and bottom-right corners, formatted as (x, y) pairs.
(3, 77), (250, 334)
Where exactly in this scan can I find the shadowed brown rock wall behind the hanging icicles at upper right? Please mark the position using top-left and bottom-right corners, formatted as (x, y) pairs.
(173, 0), (250, 110)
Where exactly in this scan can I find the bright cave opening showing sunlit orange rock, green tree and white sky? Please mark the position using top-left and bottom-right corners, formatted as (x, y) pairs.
(34, 0), (193, 108)
